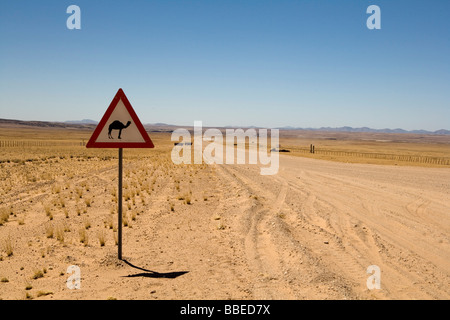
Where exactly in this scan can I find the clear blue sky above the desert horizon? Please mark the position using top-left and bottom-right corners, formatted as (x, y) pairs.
(0, 0), (450, 130)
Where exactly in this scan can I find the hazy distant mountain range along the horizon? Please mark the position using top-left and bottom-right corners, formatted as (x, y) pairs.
(0, 119), (450, 135)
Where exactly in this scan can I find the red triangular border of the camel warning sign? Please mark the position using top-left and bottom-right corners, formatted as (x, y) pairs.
(86, 88), (155, 148)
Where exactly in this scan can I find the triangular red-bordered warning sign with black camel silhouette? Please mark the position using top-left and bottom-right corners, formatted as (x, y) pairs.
(86, 89), (154, 148)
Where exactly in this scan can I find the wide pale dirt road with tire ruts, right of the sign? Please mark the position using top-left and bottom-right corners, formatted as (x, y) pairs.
(210, 157), (450, 299)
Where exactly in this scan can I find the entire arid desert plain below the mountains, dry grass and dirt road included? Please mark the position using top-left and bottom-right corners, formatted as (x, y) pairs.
(0, 124), (450, 300)
